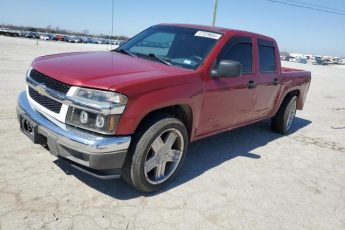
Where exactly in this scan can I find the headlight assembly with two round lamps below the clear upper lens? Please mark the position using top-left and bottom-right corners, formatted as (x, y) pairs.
(66, 88), (127, 134)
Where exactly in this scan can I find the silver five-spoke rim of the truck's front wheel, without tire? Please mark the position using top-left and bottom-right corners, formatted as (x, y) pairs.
(144, 128), (184, 184)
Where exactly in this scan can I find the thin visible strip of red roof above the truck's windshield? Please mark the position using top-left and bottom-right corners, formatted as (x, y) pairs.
(158, 23), (275, 41)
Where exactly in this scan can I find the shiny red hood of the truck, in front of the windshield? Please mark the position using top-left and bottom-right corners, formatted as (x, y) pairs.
(32, 51), (191, 90)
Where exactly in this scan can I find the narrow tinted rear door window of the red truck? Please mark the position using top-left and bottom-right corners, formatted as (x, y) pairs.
(258, 40), (276, 72)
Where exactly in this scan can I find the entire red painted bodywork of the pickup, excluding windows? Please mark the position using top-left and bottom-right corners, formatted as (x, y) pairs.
(29, 24), (311, 141)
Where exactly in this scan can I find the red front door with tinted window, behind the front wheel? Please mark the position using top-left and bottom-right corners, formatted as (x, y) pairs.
(197, 37), (255, 135)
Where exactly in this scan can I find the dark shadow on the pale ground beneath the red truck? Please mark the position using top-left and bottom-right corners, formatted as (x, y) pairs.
(54, 117), (311, 200)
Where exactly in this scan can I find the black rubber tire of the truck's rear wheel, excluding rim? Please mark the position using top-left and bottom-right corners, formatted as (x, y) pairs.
(271, 95), (297, 134)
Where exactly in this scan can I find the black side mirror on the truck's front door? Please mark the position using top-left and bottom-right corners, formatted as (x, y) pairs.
(211, 60), (242, 77)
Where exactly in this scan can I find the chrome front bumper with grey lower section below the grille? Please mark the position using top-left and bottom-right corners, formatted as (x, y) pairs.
(17, 92), (131, 179)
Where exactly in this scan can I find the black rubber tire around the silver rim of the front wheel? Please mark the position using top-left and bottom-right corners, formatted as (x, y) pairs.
(122, 114), (188, 192)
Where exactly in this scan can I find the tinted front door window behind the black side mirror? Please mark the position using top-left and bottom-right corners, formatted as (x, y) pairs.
(219, 41), (252, 73)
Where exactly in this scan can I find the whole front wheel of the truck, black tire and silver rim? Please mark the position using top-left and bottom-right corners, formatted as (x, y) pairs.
(122, 115), (188, 192)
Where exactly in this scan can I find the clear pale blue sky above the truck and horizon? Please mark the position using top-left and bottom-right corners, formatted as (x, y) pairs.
(0, 0), (345, 56)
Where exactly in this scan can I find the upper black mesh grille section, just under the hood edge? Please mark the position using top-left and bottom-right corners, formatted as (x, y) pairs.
(30, 69), (71, 95)
